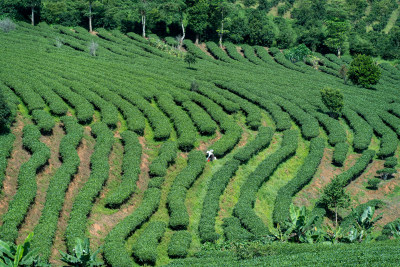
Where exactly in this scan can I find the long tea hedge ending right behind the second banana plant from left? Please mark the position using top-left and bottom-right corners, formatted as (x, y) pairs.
(65, 123), (114, 252)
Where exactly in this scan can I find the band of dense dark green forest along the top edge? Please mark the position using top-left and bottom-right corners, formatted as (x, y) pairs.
(0, 0), (400, 59)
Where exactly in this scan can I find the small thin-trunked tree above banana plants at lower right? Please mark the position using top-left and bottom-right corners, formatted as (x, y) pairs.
(321, 177), (350, 226)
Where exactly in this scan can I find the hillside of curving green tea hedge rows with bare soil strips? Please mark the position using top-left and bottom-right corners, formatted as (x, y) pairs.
(0, 23), (400, 266)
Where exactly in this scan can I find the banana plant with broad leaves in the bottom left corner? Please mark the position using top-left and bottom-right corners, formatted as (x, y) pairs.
(0, 233), (44, 267)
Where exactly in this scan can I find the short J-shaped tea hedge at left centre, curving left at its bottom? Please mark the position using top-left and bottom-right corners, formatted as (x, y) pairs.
(105, 131), (142, 208)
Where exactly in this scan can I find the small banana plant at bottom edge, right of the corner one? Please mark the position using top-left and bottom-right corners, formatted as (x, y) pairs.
(60, 238), (103, 267)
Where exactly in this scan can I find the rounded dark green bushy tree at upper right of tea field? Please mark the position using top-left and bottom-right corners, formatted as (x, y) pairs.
(348, 55), (381, 88)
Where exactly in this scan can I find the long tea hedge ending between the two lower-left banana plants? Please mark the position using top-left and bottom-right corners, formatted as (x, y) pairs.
(32, 116), (83, 261)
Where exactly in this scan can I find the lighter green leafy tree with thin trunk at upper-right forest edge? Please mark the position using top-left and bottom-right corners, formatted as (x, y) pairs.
(325, 18), (350, 57)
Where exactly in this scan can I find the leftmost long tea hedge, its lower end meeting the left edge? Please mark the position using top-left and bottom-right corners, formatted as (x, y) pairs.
(0, 124), (50, 242)
